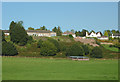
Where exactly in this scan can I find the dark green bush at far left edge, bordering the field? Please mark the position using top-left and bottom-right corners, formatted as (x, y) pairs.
(2, 41), (18, 56)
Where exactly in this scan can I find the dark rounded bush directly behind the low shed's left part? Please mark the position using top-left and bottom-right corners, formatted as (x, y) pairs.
(66, 43), (84, 56)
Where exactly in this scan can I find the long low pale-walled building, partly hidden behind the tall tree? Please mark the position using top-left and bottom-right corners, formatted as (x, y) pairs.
(3, 30), (56, 37)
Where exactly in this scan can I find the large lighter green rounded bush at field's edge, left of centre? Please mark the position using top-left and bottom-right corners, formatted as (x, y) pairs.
(40, 41), (57, 56)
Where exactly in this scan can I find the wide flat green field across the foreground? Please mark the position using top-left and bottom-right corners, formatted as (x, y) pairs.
(2, 57), (118, 80)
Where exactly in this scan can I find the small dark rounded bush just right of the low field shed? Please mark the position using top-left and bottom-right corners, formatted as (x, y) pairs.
(90, 47), (103, 58)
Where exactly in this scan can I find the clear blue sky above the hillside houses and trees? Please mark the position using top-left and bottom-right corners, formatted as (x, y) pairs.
(2, 2), (118, 32)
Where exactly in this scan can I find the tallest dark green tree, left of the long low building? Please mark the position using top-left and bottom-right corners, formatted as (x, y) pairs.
(10, 21), (28, 46)
